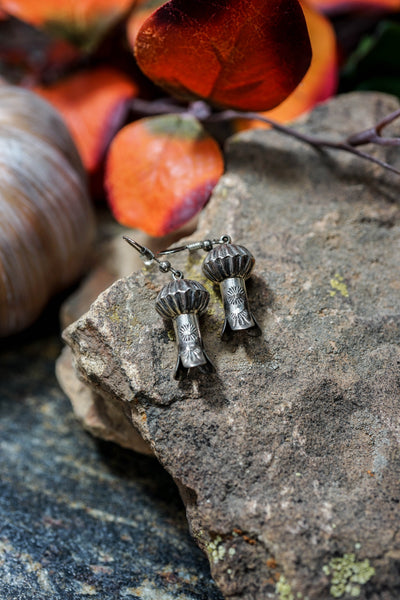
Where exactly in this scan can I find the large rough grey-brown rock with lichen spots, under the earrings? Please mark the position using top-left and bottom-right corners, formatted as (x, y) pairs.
(64, 94), (400, 600)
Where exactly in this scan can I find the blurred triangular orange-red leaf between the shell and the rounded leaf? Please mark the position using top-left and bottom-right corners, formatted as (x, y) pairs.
(35, 67), (138, 172)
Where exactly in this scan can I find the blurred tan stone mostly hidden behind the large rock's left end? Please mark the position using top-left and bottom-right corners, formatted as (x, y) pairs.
(56, 218), (197, 455)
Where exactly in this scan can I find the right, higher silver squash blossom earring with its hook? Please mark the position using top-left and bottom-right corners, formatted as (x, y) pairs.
(159, 235), (261, 339)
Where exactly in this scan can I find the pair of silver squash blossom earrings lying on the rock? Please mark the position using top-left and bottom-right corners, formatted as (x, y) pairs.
(124, 235), (261, 380)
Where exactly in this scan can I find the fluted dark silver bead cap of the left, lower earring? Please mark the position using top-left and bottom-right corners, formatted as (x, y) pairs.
(156, 279), (210, 319)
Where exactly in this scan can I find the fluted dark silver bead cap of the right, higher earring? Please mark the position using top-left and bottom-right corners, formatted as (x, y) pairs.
(203, 244), (256, 283)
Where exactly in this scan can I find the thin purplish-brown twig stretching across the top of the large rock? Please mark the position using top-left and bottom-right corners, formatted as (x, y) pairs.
(132, 99), (400, 175)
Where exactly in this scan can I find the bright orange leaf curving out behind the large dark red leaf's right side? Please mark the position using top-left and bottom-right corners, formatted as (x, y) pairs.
(236, 3), (338, 129)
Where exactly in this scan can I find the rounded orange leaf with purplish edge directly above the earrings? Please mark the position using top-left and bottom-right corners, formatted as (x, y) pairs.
(106, 115), (224, 236)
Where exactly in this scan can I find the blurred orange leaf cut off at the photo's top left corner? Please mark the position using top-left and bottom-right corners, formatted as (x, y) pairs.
(2, 0), (134, 49)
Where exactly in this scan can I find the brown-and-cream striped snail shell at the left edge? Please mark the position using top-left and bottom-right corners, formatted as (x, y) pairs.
(0, 85), (94, 336)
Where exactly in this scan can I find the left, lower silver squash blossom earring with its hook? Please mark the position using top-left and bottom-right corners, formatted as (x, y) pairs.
(123, 236), (215, 380)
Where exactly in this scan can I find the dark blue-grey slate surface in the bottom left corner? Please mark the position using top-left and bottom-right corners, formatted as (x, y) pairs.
(0, 316), (222, 600)
